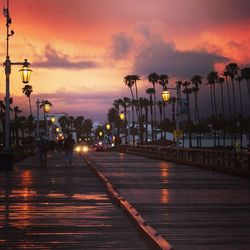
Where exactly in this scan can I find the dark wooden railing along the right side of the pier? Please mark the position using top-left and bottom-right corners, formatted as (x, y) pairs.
(116, 145), (250, 176)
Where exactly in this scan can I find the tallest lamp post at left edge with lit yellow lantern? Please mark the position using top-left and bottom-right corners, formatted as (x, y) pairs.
(1, 0), (32, 170)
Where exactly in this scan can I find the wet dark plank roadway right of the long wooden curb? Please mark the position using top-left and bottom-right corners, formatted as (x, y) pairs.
(88, 152), (250, 250)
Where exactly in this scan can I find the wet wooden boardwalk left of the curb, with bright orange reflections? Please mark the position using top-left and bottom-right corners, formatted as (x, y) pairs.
(0, 153), (150, 250)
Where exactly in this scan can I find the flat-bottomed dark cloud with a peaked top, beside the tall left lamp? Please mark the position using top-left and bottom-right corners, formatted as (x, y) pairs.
(32, 45), (97, 69)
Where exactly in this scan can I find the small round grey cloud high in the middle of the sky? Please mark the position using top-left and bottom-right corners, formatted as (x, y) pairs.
(111, 33), (133, 60)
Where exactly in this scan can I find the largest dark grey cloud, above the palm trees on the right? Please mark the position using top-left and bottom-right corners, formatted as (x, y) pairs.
(134, 37), (228, 78)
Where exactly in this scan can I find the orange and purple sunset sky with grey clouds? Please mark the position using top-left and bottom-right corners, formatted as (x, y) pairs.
(0, 0), (250, 121)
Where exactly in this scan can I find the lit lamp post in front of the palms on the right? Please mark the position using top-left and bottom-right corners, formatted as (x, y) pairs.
(162, 84), (182, 153)
